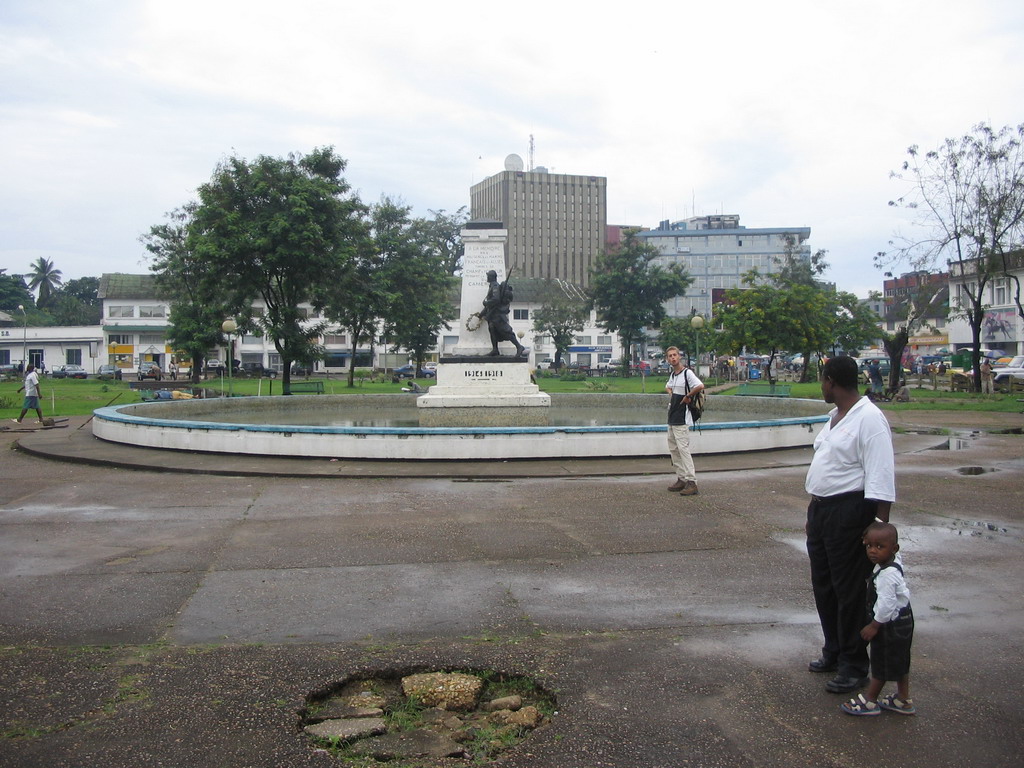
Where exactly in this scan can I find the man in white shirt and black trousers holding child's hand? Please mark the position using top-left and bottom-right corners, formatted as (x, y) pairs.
(805, 356), (896, 693)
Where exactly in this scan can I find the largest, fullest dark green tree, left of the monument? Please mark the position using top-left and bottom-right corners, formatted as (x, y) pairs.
(188, 147), (364, 393)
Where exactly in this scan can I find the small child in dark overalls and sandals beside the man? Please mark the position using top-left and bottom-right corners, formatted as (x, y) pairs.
(840, 522), (918, 715)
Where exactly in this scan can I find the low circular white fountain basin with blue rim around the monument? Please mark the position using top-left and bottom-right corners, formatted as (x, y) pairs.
(92, 394), (828, 461)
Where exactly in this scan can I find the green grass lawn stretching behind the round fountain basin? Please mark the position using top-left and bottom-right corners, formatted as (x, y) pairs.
(0, 376), (1021, 421)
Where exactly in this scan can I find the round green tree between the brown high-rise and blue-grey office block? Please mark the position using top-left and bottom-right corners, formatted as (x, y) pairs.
(590, 229), (692, 376)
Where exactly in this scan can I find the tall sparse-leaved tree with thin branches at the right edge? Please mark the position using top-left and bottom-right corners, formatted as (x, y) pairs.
(876, 123), (1024, 388)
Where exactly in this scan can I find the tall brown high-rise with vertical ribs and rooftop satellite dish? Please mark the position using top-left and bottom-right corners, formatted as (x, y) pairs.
(470, 167), (608, 286)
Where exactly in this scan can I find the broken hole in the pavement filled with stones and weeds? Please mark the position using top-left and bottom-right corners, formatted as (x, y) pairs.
(299, 671), (556, 768)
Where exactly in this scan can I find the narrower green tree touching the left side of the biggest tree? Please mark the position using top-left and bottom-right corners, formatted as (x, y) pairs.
(139, 203), (227, 384)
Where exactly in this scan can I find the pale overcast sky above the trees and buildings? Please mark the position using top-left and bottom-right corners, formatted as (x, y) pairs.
(0, 0), (1024, 296)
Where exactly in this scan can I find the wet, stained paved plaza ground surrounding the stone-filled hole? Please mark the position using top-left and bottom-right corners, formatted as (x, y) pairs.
(0, 412), (1024, 768)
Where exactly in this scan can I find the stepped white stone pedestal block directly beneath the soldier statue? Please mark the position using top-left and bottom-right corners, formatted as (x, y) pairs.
(416, 355), (551, 427)
